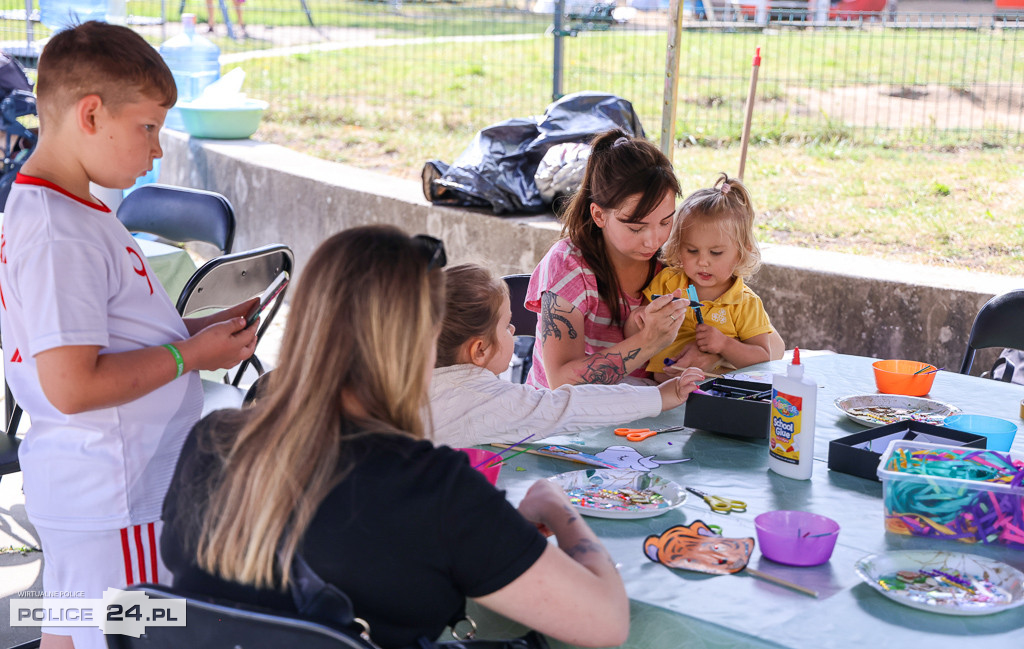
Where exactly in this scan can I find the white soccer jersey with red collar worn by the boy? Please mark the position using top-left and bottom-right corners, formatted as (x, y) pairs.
(0, 175), (203, 530)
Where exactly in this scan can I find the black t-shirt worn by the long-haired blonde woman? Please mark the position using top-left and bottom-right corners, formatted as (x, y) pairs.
(161, 413), (547, 647)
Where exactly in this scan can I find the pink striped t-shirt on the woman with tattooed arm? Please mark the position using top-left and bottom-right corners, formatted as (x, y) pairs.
(525, 239), (650, 388)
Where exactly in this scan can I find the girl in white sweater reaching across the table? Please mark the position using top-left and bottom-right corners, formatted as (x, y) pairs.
(430, 264), (705, 447)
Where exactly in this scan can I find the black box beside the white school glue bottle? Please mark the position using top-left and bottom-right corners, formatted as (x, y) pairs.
(683, 379), (771, 439)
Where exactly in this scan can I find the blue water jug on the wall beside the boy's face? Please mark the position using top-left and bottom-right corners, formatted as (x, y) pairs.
(160, 13), (220, 131)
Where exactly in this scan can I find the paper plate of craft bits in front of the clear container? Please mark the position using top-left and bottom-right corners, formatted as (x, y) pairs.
(855, 551), (1024, 615)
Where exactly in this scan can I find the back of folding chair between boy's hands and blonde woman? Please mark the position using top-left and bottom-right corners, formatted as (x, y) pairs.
(177, 244), (295, 384)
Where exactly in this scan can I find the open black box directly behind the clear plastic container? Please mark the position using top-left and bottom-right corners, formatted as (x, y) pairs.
(828, 422), (988, 482)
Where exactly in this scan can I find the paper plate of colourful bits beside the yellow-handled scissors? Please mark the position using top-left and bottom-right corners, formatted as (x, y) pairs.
(548, 469), (686, 518)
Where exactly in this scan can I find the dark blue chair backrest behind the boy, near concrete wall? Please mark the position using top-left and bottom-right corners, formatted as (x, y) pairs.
(118, 184), (234, 255)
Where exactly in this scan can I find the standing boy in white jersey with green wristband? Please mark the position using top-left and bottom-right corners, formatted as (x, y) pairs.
(0, 23), (256, 649)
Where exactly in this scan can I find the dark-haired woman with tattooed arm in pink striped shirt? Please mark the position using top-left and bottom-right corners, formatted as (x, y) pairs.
(526, 130), (688, 388)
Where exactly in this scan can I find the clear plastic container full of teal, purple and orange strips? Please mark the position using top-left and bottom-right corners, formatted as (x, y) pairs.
(879, 440), (1024, 549)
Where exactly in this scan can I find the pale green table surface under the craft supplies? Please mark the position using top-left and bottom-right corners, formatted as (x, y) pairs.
(470, 353), (1024, 649)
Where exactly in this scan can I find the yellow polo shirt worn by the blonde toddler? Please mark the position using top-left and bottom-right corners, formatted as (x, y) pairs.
(643, 268), (773, 372)
